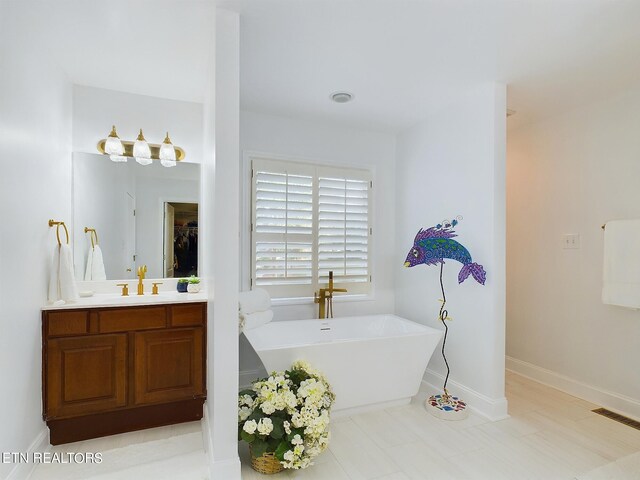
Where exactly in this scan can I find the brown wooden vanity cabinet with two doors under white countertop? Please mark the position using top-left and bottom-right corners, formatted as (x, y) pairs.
(42, 302), (207, 445)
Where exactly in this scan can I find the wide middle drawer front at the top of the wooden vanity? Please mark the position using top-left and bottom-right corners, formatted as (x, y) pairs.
(98, 306), (167, 333)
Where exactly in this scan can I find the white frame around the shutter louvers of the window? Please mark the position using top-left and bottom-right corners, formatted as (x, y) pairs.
(245, 154), (374, 303)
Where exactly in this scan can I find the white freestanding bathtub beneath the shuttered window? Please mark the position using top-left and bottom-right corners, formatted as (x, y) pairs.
(245, 315), (442, 414)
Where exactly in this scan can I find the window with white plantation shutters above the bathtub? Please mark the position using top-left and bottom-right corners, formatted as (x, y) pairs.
(251, 158), (372, 298)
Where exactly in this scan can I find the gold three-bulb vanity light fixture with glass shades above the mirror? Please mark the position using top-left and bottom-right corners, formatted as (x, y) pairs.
(98, 125), (185, 167)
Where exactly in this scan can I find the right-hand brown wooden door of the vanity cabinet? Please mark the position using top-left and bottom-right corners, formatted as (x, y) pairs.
(134, 328), (204, 405)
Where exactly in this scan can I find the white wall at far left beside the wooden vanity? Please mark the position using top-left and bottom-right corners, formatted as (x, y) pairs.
(0, 2), (71, 478)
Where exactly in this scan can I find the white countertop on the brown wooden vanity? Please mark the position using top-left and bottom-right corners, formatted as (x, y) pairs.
(42, 290), (208, 310)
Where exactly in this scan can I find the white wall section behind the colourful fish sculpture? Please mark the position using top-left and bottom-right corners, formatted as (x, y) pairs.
(394, 84), (507, 418)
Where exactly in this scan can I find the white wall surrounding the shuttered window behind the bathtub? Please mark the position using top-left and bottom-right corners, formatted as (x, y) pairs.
(240, 111), (397, 377)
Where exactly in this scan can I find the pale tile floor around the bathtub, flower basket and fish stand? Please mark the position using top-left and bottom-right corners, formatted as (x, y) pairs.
(240, 372), (640, 480)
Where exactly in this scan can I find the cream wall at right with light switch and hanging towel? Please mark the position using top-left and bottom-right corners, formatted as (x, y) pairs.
(507, 86), (640, 418)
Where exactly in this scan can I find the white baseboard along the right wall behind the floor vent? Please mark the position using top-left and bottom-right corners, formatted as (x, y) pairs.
(505, 357), (640, 419)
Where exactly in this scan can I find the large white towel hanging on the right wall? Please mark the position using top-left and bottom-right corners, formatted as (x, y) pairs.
(602, 220), (640, 308)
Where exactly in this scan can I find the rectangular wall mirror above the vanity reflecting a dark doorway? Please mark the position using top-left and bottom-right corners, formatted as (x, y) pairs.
(73, 153), (200, 281)
